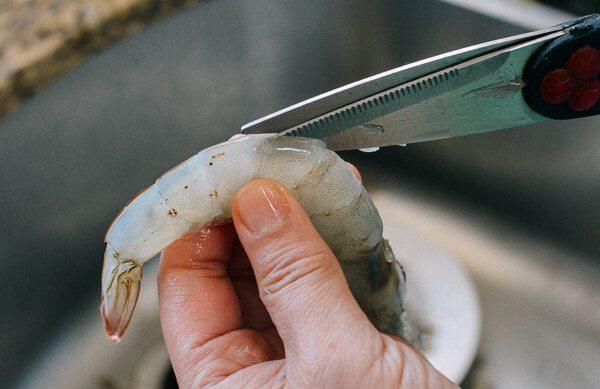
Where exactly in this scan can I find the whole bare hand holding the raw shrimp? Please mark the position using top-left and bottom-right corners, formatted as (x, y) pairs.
(158, 172), (457, 388)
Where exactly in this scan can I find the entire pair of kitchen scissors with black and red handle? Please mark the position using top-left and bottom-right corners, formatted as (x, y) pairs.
(242, 14), (600, 151)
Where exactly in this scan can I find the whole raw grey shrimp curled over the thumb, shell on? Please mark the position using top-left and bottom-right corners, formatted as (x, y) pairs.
(100, 135), (418, 342)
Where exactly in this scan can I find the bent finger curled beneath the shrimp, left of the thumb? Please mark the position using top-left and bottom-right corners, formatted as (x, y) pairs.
(158, 224), (242, 372)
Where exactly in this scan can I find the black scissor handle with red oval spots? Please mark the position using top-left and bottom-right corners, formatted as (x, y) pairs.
(523, 14), (600, 119)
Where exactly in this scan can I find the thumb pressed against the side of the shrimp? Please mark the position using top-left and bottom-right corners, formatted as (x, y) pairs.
(232, 179), (378, 356)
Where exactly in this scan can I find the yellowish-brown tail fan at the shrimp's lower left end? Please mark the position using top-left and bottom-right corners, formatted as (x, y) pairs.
(100, 248), (142, 343)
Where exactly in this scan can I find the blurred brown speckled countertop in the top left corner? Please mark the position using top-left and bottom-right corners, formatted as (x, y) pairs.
(0, 0), (197, 116)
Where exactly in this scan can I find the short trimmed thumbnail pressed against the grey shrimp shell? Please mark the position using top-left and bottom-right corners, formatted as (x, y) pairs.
(236, 181), (290, 237)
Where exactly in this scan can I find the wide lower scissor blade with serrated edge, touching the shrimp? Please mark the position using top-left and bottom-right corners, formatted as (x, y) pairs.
(314, 31), (563, 150)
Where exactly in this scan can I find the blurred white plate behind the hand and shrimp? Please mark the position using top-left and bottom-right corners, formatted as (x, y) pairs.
(373, 193), (481, 382)
